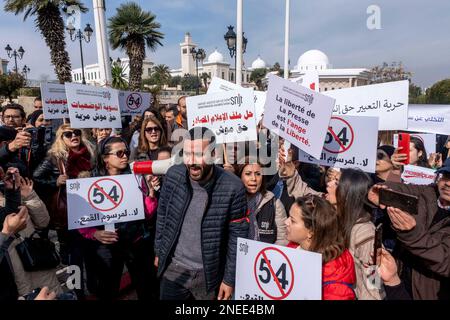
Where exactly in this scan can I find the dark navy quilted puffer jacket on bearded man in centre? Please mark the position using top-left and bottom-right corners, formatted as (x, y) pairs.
(155, 164), (248, 292)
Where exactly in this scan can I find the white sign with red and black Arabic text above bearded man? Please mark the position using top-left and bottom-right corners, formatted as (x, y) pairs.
(186, 88), (257, 143)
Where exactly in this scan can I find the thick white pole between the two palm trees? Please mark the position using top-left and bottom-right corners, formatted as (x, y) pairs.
(93, 0), (112, 85)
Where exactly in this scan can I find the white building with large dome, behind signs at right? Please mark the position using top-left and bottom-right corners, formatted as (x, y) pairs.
(291, 50), (370, 91)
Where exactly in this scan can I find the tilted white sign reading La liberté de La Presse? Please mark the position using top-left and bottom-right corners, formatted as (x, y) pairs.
(263, 74), (334, 158)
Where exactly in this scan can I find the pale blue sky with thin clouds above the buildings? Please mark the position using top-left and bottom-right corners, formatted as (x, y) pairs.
(0, 0), (450, 87)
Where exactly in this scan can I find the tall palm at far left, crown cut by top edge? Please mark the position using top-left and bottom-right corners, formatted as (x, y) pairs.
(5, 0), (87, 83)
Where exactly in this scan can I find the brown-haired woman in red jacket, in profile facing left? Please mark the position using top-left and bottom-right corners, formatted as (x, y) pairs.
(286, 195), (356, 300)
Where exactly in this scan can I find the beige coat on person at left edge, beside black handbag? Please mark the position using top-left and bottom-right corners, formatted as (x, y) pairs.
(0, 190), (62, 295)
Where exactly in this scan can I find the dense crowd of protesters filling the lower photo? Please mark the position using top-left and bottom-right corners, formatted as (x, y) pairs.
(0, 78), (450, 301)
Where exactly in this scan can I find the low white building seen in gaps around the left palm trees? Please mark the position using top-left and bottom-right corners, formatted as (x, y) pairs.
(72, 58), (154, 85)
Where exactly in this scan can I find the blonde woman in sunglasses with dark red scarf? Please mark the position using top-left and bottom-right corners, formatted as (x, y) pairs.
(33, 124), (95, 298)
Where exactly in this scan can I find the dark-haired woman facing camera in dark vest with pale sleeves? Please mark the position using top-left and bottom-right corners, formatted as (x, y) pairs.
(237, 157), (287, 245)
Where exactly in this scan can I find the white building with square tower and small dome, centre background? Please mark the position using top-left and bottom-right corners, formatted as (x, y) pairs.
(170, 32), (265, 86)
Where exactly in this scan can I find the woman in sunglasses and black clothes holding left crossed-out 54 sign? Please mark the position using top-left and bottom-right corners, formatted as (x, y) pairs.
(79, 136), (158, 300)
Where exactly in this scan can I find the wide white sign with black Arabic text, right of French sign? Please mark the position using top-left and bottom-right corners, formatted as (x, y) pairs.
(323, 80), (409, 130)
